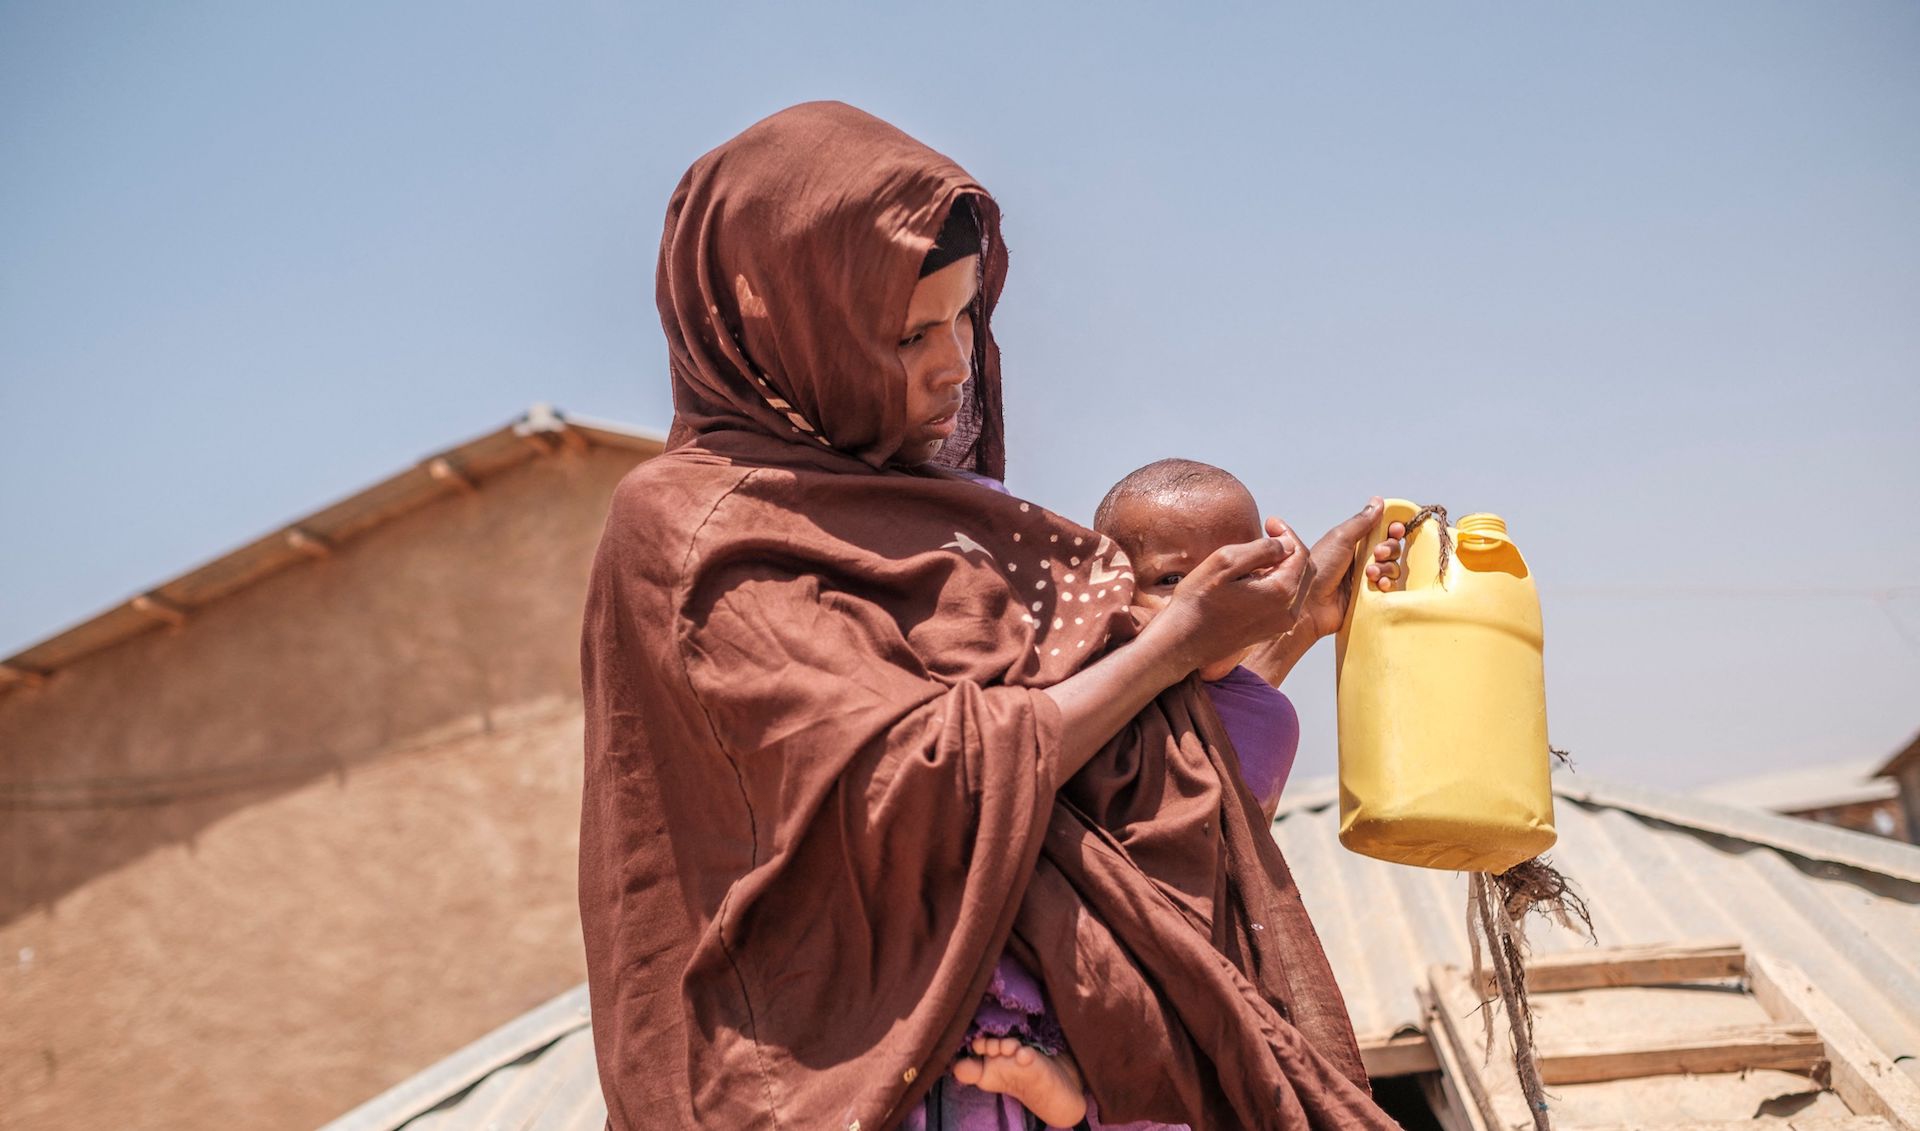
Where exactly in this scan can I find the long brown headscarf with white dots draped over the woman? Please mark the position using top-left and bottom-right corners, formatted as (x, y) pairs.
(580, 104), (1392, 1131)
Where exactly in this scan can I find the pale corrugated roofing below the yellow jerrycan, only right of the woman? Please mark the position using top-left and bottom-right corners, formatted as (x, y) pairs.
(1273, 776), (1920, 1073)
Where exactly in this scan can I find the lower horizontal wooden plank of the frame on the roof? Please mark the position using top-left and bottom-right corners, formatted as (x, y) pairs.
(1540, 1025), (1845, 1098)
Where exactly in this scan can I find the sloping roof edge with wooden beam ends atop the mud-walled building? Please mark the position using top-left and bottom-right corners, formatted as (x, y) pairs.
(0, 405), (664, 693)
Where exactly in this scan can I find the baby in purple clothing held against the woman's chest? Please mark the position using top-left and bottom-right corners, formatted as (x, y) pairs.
(936, 459), (1328, 1127)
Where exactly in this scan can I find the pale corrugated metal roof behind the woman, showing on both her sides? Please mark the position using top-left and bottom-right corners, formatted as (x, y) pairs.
(323, 776), (1920, 1131)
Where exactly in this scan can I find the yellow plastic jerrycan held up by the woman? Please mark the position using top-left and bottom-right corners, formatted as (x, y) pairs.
(1336, 499), (1555, 872)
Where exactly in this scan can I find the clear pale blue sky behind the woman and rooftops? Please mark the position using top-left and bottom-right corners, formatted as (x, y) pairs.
(0, 0), (1920, 785)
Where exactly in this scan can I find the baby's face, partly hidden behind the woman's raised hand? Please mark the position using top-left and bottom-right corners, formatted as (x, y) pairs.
(1112, 486), (1265, 680)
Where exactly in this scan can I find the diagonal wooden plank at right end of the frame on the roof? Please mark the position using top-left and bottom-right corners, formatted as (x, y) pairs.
(1747, 954), (1920, 1131)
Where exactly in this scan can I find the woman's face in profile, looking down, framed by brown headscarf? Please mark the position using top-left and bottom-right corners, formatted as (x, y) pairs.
(893, 255), (979, 467)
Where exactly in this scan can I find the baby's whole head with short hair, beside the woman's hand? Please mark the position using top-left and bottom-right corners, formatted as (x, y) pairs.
(1092, 459), (1267, 680)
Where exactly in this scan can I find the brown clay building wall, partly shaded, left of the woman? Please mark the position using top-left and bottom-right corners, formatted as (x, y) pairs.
(0, 447), (641, 1129)
